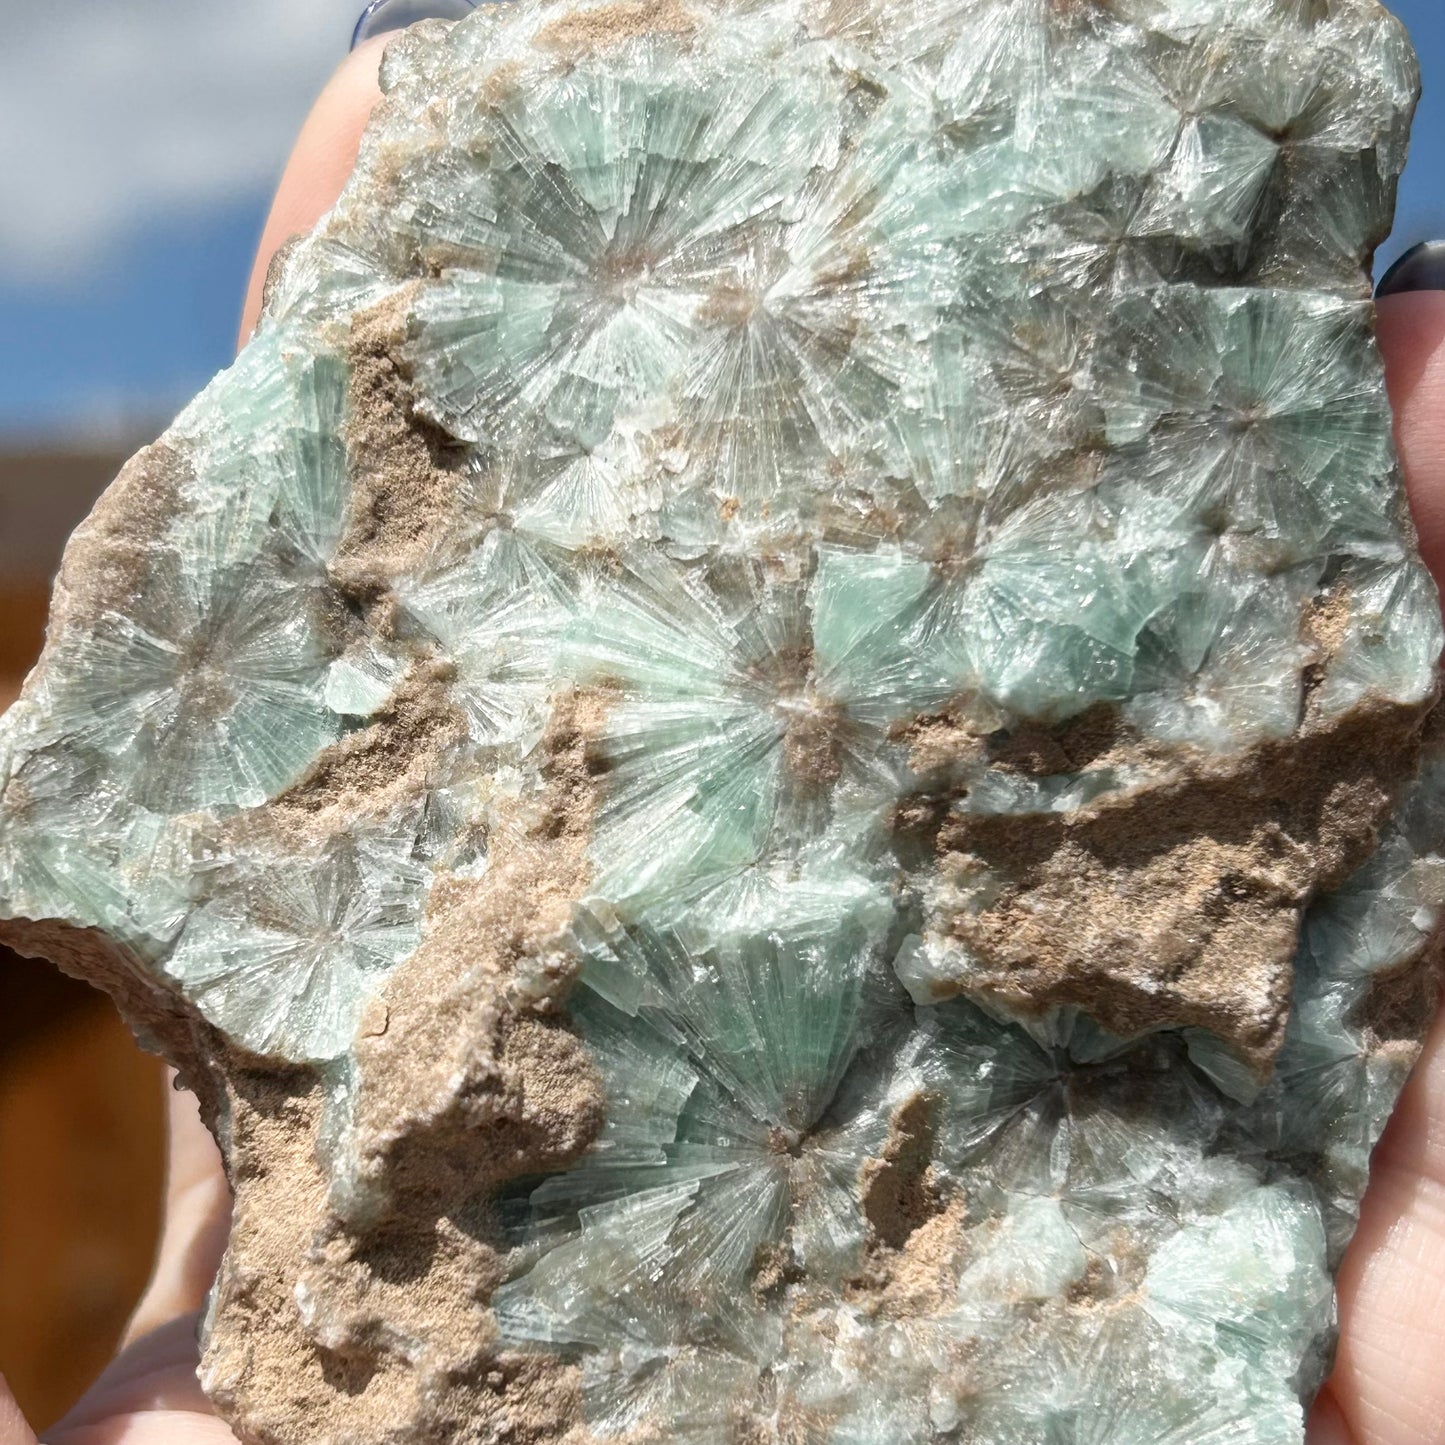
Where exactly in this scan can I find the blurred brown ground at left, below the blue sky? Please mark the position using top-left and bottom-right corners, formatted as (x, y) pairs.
(0, 448), (165, 1429)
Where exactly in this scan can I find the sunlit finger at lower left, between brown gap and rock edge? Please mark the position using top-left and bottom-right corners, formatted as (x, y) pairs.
(123, 1069), (231, 1345)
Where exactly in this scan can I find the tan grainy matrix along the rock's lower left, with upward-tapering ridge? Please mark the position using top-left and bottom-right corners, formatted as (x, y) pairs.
(0, 692), (610, 1445)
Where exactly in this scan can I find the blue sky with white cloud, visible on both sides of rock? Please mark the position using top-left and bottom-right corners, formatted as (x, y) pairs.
(0, 0), (1445, 444)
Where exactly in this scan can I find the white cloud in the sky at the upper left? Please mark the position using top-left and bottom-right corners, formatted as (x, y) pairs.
(0, 0), (363, 282)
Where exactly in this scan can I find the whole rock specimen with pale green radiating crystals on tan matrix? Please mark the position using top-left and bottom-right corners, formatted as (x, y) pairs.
(0, 0), (1445, 1445)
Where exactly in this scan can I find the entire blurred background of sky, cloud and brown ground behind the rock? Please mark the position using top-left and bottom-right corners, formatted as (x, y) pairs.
(0, 0), (1445, 1428)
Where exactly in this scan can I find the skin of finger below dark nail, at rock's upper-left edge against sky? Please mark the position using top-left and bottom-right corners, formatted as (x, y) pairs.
(240, 35), (393, 345)
